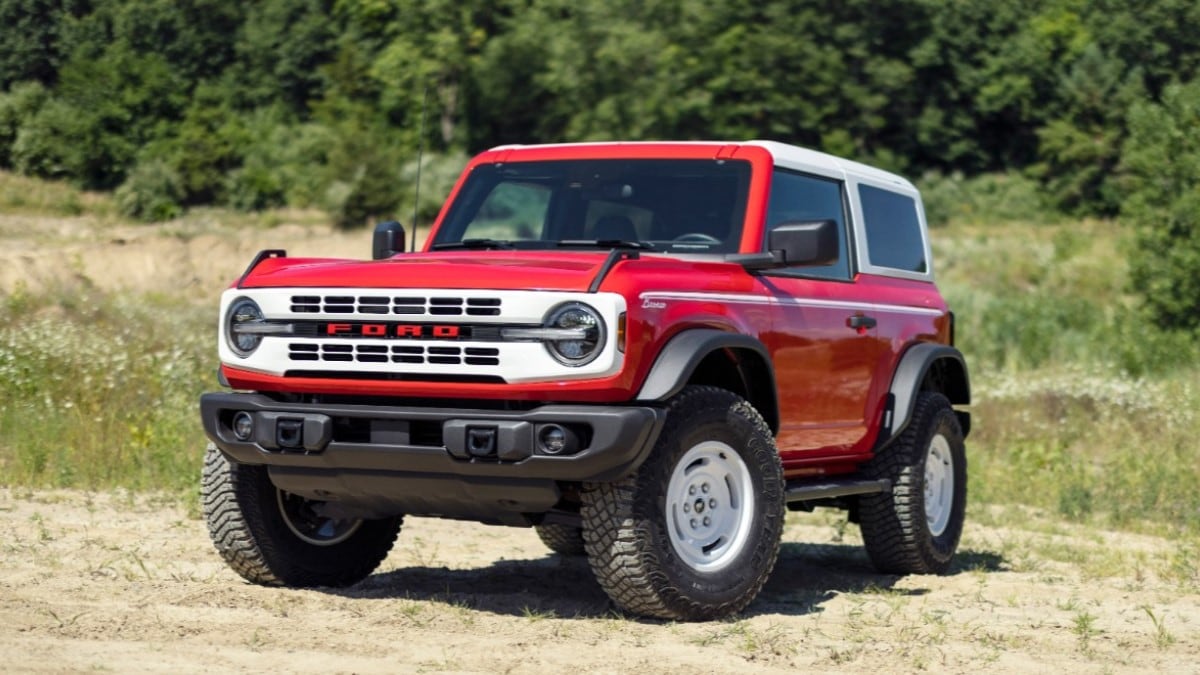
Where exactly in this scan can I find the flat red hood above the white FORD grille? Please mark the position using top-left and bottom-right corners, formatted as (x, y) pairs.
(241, 251), (607, 291)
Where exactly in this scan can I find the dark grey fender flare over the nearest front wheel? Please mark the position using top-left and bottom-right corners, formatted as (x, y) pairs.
(635, 328), (779, 429)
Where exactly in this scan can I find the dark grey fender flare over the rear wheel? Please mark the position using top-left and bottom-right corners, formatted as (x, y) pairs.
(876, 342), (971, 447)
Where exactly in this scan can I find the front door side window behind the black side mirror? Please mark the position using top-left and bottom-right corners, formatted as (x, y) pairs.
(763, 169), (850, 279)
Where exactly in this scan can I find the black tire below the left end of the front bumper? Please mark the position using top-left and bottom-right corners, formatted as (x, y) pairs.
(200, 443), (403, 586)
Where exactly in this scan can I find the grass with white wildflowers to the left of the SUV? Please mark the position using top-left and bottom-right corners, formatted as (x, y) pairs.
(0, 283), (216, 494)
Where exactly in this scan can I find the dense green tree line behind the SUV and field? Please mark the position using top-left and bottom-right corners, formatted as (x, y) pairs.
(0, 0), (1200, 329)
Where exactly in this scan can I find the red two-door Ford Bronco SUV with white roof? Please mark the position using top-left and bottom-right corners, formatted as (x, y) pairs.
(200, 142), (970, 620)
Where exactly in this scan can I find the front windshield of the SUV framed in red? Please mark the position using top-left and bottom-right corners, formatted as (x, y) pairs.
(432, 160), (750, 253)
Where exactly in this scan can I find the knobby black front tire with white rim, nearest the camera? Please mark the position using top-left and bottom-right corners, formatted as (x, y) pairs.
(581, 387), (786, 621)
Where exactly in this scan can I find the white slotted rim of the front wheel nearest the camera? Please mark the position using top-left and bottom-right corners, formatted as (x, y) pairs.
(666, 441), (755, 572)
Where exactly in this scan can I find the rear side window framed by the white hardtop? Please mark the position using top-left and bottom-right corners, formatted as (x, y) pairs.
(858, 185), (929, 274)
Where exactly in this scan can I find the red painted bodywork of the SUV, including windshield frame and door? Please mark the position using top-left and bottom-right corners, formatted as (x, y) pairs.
(223, 143), (949, 477)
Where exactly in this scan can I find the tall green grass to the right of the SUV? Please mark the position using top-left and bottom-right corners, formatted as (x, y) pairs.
(935, 216), (1200, 534)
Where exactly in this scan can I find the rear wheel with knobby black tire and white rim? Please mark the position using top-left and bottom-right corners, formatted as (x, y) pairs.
(858, 392), (967, 574)
